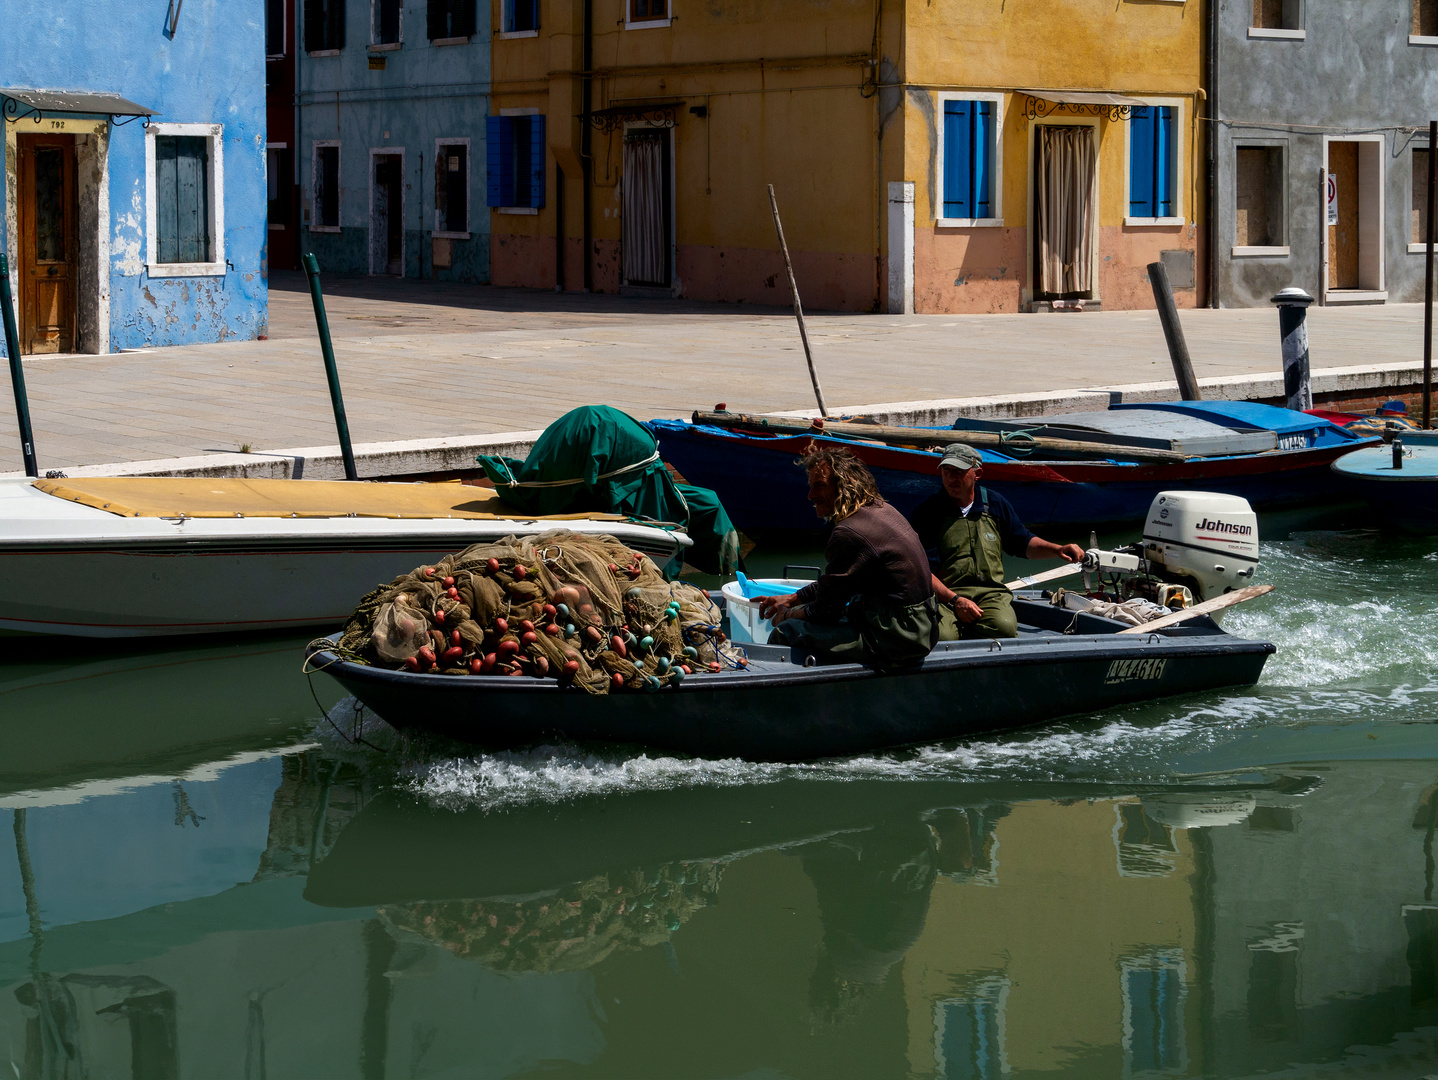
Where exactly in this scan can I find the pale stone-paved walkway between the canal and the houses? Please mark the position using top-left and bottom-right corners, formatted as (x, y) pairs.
(0, 273), (1422, 472)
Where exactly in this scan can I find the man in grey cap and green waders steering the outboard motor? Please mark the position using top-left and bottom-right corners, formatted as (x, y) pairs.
(913, 443), (1083, 641)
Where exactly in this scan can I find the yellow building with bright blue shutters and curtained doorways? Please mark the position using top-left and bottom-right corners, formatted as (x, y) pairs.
(486, 0), (1208, 314)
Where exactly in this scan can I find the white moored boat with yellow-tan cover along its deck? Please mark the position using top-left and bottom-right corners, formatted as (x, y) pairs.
(0, 477), (690, 637)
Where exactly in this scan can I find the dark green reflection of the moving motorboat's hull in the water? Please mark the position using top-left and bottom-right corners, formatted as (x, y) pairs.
(305, 779), (1271, 907)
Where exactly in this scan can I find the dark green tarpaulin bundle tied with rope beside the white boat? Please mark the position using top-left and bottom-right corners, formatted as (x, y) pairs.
(476, 406), (741, 577)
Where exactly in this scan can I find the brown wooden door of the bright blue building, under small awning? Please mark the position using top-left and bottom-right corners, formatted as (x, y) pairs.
(17, 135), (78, 352)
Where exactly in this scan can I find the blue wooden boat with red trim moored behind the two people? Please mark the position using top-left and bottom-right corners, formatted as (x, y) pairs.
(650, 401), (1376, 534)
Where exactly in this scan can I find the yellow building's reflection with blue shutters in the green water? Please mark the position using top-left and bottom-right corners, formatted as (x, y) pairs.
(903, 800), (1198, 1080)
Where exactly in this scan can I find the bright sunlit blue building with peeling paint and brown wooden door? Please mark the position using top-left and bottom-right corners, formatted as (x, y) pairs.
(0, 0), (267, 352)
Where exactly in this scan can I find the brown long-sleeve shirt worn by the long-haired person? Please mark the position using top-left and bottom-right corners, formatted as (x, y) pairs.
(795, 503), (933, 621)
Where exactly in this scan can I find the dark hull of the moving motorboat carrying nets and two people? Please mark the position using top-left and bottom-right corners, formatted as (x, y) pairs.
(308, 591), (1274, 761)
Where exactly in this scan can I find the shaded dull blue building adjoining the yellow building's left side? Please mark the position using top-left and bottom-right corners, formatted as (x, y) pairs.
(295, 0), (491, 282)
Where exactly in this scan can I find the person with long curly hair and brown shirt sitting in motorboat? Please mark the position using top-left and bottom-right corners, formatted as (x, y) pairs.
(759, 444), (939, 667)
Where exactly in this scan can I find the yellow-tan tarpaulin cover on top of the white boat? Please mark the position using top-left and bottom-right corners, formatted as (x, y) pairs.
(35, 476), (624, 521)
